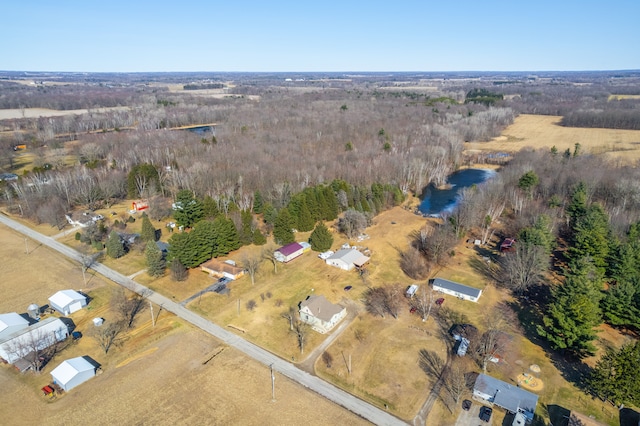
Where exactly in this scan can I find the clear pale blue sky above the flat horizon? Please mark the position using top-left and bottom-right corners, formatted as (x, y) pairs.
(0, 0), (640, 72)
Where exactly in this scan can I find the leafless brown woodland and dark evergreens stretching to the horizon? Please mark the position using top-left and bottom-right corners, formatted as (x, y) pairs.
(0, 72), (640, 412)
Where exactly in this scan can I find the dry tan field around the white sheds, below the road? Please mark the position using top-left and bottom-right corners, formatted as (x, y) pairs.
(0, 226), (366, 425)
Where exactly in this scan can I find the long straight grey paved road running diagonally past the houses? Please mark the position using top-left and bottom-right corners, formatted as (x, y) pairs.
(0, 214), (406, 425)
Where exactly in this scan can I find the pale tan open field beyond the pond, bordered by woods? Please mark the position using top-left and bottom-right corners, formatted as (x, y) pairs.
(465, 114), (640, 164)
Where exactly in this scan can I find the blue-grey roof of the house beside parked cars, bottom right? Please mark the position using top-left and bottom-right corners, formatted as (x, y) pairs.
(473, 374), (538, 419)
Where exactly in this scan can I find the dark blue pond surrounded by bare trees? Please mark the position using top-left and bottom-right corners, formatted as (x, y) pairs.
(418, 169), (496, 216)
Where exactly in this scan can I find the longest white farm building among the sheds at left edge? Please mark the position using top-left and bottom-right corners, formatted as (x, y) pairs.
(0, 317), (69, 364)
